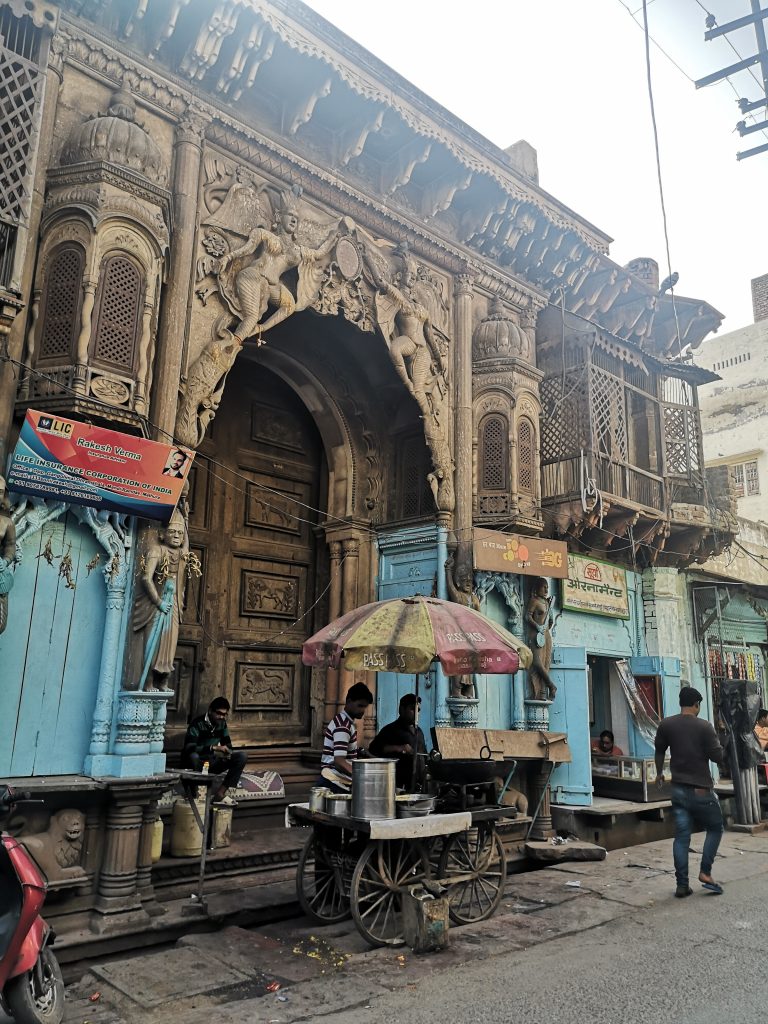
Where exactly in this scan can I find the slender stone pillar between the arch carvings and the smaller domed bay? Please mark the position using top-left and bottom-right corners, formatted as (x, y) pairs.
(455, 273), (473, 571)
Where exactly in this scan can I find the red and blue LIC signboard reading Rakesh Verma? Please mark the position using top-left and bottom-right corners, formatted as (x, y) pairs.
(7, 410), (195, 522)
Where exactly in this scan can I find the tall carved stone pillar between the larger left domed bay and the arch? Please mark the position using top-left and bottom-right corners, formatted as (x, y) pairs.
(151, 111), (208, 439)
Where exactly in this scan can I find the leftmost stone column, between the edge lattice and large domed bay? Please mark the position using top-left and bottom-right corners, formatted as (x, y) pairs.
(0, 51), (63, 467)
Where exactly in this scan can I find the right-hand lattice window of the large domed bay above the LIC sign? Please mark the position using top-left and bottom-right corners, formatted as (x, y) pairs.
(91, 253), (144, 373)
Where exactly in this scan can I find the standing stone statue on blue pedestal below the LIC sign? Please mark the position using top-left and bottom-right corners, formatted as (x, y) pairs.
(133, 511), (189, 690)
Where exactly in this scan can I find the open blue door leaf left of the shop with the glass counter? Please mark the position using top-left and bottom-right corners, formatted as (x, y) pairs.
(549, 647), (592, 807)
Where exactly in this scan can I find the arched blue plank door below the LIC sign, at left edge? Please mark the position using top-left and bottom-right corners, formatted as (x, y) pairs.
(0, 515), (105, 776)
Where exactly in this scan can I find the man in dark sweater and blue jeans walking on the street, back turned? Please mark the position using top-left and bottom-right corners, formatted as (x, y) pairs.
(655, 686), (723, 898)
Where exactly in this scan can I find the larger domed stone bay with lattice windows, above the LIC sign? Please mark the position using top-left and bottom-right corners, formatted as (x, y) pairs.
(18, 91), (170, 431)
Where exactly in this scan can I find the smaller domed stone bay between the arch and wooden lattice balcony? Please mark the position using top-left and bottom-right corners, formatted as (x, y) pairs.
(472, 298), (544, 534)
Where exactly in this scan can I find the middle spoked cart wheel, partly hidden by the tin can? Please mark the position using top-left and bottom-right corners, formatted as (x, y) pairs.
(349, 839), (429, 946)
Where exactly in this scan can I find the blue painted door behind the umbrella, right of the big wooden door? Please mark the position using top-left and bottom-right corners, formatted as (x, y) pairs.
(376, 528), (437, 750)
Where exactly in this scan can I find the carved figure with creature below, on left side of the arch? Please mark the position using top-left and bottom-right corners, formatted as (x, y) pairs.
(175, 188), (354, 447)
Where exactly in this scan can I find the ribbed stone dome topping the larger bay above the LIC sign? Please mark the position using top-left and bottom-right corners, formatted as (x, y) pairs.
(60, 91), (166, 184)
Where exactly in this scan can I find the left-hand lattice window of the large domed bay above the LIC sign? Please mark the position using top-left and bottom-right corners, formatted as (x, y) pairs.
(38, 243), (85, 364)
